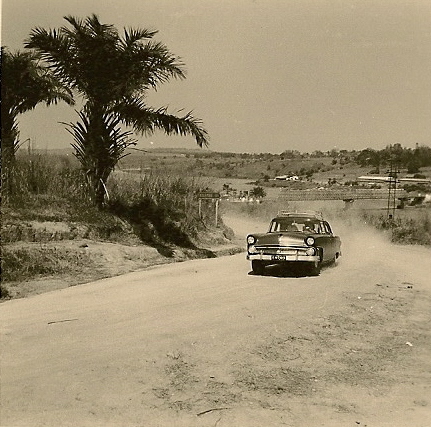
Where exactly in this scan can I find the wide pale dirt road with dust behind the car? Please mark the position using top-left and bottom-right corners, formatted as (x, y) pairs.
(0, 218), (431, 427)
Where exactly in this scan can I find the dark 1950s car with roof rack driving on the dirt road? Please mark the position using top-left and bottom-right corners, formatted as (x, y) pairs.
(247, 211), (341, 276)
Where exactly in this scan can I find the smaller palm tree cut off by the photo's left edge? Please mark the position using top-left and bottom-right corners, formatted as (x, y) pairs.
(1, 46), (74, 193)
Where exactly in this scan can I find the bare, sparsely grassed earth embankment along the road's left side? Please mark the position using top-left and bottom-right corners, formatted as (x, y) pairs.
(1, 214), (242, 300)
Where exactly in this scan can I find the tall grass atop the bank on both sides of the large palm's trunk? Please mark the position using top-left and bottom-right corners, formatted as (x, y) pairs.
(2, 154), (219, 244)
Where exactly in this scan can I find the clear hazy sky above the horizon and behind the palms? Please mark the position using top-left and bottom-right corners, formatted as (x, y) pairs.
(1, 0), (431, 153)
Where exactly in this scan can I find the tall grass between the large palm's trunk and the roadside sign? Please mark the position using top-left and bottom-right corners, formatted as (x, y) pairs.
(108, 173), (213, 247)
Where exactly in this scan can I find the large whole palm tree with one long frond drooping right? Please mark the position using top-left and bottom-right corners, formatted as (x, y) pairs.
(26, 14), (208, 206)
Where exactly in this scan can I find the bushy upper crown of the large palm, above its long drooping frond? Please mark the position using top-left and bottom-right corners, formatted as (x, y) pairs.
(25, 15), (189, 103)
